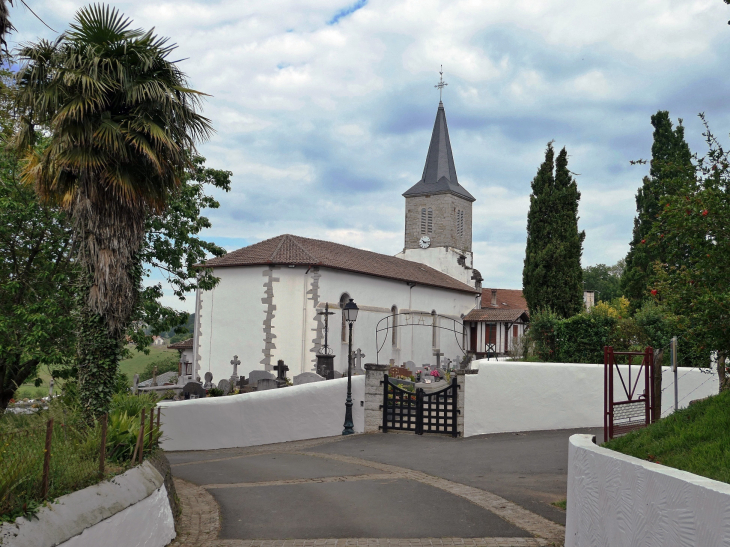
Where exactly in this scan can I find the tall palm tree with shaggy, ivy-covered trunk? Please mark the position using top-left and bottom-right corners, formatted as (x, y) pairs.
(16, 5), (212, 419)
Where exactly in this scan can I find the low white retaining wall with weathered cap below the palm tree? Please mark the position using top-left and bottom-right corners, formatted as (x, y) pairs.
(0, 462), (175, 547)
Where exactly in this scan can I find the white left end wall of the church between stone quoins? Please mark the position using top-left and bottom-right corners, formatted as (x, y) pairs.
(198, 266), (268, 383)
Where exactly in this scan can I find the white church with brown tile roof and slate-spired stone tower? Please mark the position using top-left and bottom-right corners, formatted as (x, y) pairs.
(190, 97), (522, 381)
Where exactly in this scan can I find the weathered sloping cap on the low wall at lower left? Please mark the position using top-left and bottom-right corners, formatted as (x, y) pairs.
(0, 462), (164, 547)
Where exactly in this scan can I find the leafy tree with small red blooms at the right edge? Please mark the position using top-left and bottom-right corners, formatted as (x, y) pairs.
(647, 115), (730, 389)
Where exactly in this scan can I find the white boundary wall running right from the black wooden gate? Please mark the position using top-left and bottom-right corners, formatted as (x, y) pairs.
(464, 359), (718, 437)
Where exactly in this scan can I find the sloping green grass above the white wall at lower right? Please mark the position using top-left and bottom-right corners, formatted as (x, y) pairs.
(604, 391), (730, 483)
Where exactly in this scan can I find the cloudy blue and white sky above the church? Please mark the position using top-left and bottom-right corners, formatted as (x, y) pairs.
(9, 0), (730, 311)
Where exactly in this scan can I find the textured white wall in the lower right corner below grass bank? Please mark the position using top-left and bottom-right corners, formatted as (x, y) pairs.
(564, 434), (730, 547)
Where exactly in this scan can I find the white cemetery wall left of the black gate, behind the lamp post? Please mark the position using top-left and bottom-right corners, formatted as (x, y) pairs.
(159, 375), (365, 450)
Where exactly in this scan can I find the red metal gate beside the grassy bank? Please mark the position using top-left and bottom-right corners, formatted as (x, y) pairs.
(603, 346), (655, 441)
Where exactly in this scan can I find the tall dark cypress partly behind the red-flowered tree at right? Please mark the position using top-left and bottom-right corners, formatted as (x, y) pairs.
(621, 110), (695, 309)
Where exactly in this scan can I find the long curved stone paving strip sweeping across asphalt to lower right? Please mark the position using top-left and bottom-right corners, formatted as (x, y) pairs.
(299, 452), (565, 544)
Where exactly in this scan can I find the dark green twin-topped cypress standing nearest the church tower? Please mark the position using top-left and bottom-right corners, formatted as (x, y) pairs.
(522, 142), (585, 317)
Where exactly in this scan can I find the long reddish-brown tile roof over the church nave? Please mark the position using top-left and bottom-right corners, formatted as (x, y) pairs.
(204, 234), (476, 294)
